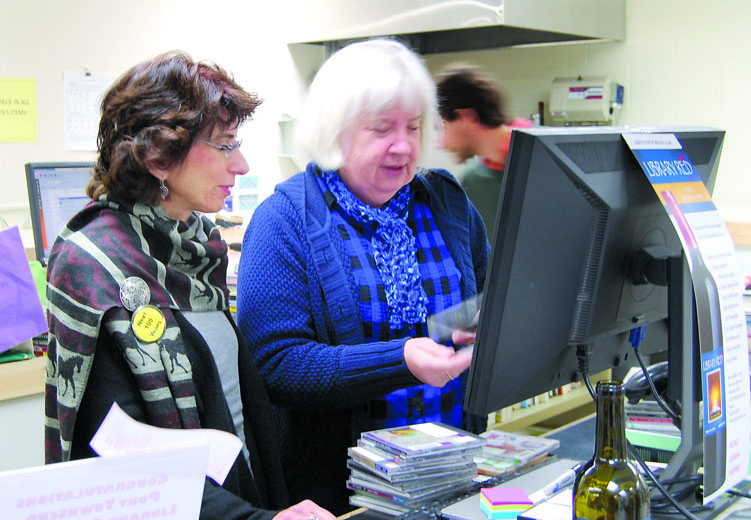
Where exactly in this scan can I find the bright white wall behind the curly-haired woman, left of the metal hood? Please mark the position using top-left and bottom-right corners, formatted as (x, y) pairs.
(0, 0), (322, 234)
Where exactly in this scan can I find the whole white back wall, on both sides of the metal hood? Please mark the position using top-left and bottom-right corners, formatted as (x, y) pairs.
(0, 0), (751, 232)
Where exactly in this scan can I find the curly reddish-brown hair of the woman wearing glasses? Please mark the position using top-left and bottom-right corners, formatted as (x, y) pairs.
(86, 51), (261, 205)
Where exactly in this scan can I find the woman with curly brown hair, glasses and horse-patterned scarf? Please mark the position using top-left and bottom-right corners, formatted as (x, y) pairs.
(45, 52), (333, 520)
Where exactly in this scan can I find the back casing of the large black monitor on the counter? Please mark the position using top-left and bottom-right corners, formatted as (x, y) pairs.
(465, 127), (724, 415)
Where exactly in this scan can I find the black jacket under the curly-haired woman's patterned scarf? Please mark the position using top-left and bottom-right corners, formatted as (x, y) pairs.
(71, 312), (291, 520)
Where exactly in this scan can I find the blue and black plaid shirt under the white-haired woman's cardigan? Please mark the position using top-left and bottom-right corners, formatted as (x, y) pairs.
(318, 177), (463, 429)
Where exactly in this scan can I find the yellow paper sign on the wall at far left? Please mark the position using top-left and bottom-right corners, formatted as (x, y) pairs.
(0, 78), (37, 143)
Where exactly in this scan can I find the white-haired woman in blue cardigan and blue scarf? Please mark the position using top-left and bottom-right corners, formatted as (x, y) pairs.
(238, 40), (489, 514)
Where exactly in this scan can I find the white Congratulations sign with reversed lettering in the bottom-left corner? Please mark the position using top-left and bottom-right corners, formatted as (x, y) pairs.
(0, 443), (208, 520)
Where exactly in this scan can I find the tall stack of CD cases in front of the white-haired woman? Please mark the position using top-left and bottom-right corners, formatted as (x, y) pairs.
(347, 423), (483, 516)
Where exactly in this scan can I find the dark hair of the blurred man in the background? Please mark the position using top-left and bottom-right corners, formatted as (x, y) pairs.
(437, 65), (508, 128)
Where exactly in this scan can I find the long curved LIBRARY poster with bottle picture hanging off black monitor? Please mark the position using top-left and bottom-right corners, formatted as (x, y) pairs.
(623, 133), (751, 503)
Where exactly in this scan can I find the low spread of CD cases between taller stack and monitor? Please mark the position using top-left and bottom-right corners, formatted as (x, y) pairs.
(475, 430), (561, 476)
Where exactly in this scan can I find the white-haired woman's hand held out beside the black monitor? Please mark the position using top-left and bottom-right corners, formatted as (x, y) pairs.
(404, 338), (472, 388)
